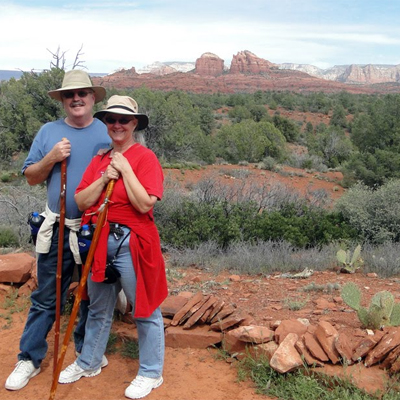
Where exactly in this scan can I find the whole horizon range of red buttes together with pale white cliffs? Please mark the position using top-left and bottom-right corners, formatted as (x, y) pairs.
(93, 50), (400, 93)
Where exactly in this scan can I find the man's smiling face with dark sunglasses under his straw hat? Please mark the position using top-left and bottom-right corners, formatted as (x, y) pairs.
(61, 89), (95, 120)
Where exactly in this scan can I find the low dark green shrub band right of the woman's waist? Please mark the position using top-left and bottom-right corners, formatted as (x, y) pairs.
(159, 199), (355, 248)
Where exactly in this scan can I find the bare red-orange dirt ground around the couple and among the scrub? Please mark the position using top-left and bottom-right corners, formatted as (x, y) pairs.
(0, 166), (400, 400)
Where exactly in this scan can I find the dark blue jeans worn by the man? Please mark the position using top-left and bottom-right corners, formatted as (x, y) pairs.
(18, 225), (85, 368)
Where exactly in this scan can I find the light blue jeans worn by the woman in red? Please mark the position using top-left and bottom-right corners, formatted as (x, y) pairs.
(77, 228), (165, 378)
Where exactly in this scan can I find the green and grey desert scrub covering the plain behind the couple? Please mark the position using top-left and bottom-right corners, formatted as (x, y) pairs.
(0, 68), (400, 399)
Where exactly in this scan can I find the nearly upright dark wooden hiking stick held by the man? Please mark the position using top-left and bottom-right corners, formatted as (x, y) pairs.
(53, 154), (67, 371)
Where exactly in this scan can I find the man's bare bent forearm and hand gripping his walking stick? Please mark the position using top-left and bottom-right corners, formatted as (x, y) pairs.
(24, 139), (71, 186)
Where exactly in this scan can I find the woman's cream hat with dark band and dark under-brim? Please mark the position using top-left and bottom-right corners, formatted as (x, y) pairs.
(94, 95), (149, 131)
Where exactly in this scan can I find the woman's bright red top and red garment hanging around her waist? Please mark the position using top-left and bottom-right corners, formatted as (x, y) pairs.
(76, 143), (168, 318)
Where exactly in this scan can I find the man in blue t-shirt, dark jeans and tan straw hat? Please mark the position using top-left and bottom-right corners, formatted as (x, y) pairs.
(5, 70), (110, 390)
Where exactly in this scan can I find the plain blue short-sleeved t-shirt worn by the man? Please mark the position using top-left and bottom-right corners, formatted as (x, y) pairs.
(22, 118), (111, 219)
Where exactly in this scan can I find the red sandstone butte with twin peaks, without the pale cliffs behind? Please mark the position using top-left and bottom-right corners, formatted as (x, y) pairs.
(92, 51), (400, 93)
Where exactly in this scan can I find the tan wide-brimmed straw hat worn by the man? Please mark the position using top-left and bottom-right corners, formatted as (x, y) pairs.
(48, 69), (106, 103)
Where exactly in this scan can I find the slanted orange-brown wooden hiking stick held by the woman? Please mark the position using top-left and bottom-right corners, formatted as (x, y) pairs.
(49, 179), (115, 400)
